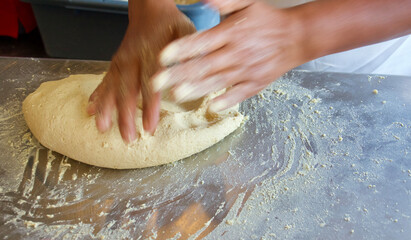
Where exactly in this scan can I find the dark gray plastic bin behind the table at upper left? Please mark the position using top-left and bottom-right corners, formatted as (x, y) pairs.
(23, 0), (128, 60)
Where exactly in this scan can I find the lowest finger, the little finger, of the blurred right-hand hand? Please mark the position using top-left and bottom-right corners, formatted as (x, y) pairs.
(208, 82), (260, 112)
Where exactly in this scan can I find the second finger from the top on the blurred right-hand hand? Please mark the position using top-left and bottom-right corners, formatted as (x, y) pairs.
(153, 46), (239, 92)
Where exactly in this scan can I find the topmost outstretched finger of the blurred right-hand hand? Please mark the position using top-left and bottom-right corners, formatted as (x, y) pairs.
(160, 25), (229, 66)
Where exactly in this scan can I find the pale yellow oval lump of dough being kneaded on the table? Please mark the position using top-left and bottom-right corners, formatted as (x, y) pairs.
(23, 75), (243, 169)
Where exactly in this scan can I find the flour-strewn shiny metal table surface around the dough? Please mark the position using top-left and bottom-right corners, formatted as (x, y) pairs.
(0, 58), (411, 239)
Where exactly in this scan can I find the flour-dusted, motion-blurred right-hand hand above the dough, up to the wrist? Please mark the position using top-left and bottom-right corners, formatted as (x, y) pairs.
(153, 0), (305, 111)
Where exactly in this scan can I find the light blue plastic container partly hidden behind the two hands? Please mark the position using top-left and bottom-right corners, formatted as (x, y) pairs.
(177, 2), (220, 31)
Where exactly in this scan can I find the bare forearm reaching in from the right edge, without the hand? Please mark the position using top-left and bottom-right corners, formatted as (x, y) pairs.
(286, 0), (411, 61)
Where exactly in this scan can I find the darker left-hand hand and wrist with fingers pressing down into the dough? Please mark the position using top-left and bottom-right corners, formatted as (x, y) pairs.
(87, 0), (195, 142)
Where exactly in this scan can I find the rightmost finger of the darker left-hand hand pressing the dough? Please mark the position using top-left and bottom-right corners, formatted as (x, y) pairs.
(143, 91), (161, 135)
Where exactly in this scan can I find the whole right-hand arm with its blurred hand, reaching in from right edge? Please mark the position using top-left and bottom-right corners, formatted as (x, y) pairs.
(153, 0), (411, 111)
